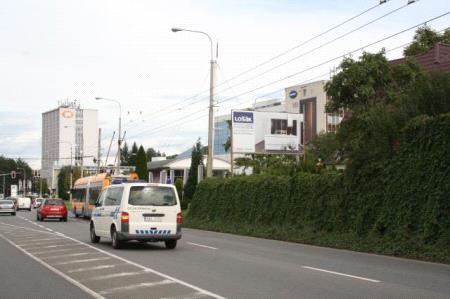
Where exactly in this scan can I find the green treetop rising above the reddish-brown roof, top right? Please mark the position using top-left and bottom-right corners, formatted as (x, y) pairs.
(403, 26), (450, 56)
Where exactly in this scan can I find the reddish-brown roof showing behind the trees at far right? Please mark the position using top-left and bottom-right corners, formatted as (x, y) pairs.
(391, 43), (450, 72)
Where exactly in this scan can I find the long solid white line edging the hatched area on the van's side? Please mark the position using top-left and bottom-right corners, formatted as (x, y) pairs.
(2, 223), (225, 299)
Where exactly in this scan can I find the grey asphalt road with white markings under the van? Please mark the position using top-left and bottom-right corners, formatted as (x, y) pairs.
(0, 211), (450, 298)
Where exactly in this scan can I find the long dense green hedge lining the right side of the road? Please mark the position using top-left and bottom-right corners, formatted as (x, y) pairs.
(186, 115), (450, 263)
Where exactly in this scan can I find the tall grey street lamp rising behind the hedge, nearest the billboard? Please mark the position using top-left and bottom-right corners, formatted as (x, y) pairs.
(172, 27), (217, 177)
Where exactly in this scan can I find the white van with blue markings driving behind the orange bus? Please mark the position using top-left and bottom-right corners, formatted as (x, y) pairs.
(90, 183), (181, 249)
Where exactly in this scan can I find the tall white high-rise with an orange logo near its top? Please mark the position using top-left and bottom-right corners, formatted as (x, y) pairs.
(41, 102), (98, 189)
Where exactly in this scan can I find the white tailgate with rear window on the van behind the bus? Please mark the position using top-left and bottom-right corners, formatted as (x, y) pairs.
(127, 185), (180, 237)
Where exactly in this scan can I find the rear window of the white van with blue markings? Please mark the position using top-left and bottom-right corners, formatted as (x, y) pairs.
(128, 186), (177, 206)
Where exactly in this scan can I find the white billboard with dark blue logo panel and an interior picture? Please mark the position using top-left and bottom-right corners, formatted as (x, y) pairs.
(231, 110), (303, 154)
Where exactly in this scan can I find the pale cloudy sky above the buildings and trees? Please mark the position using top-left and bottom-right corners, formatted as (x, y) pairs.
(0, 0), (450, 168)
